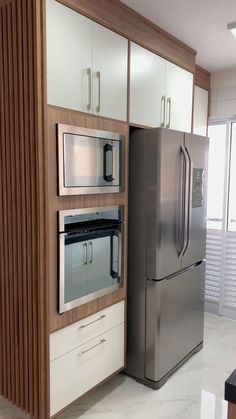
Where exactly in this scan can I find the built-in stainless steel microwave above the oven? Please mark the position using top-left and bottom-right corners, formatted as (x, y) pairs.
(57, 124), (124, 195)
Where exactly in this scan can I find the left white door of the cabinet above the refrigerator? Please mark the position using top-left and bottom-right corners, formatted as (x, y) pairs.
(130, 42), (166, 127)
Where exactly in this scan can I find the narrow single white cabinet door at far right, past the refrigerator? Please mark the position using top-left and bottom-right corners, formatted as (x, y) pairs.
(193, 86), (208, 136)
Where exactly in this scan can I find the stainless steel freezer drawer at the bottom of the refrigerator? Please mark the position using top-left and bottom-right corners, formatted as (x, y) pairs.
(145, 263), (204, 381)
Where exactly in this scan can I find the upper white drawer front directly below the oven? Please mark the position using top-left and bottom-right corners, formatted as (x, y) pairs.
(50, 301), (124, 361)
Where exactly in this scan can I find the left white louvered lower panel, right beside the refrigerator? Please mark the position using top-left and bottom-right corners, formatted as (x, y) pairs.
(205, 230), (222, 304)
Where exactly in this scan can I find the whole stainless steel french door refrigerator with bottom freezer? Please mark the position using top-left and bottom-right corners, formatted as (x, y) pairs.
(126, 128), (208, 389)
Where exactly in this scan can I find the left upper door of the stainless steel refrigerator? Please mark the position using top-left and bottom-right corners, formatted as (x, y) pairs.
(146, 128), (184, 279)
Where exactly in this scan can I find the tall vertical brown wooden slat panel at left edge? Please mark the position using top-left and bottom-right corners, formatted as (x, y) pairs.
(0, 0), (49, 419)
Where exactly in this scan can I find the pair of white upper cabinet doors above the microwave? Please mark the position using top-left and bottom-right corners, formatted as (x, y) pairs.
(47, 0), (128, 120)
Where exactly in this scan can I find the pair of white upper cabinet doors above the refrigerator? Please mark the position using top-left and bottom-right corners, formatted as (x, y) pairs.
(130, 43), (193, 132)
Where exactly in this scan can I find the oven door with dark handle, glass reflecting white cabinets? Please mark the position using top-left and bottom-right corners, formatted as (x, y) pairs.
(59, 228), (122, 314)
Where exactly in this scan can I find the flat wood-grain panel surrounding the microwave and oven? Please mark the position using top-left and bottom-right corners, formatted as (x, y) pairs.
(47, 106), (128, 332)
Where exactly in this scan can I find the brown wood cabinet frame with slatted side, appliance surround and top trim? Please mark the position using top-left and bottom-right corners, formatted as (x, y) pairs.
(0, 0), (199, 419)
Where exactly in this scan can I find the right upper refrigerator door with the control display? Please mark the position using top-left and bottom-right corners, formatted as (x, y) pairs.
(182, 134), (208, 268)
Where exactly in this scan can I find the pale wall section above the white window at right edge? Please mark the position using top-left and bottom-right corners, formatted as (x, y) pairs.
(210, 70), (236, 118)
